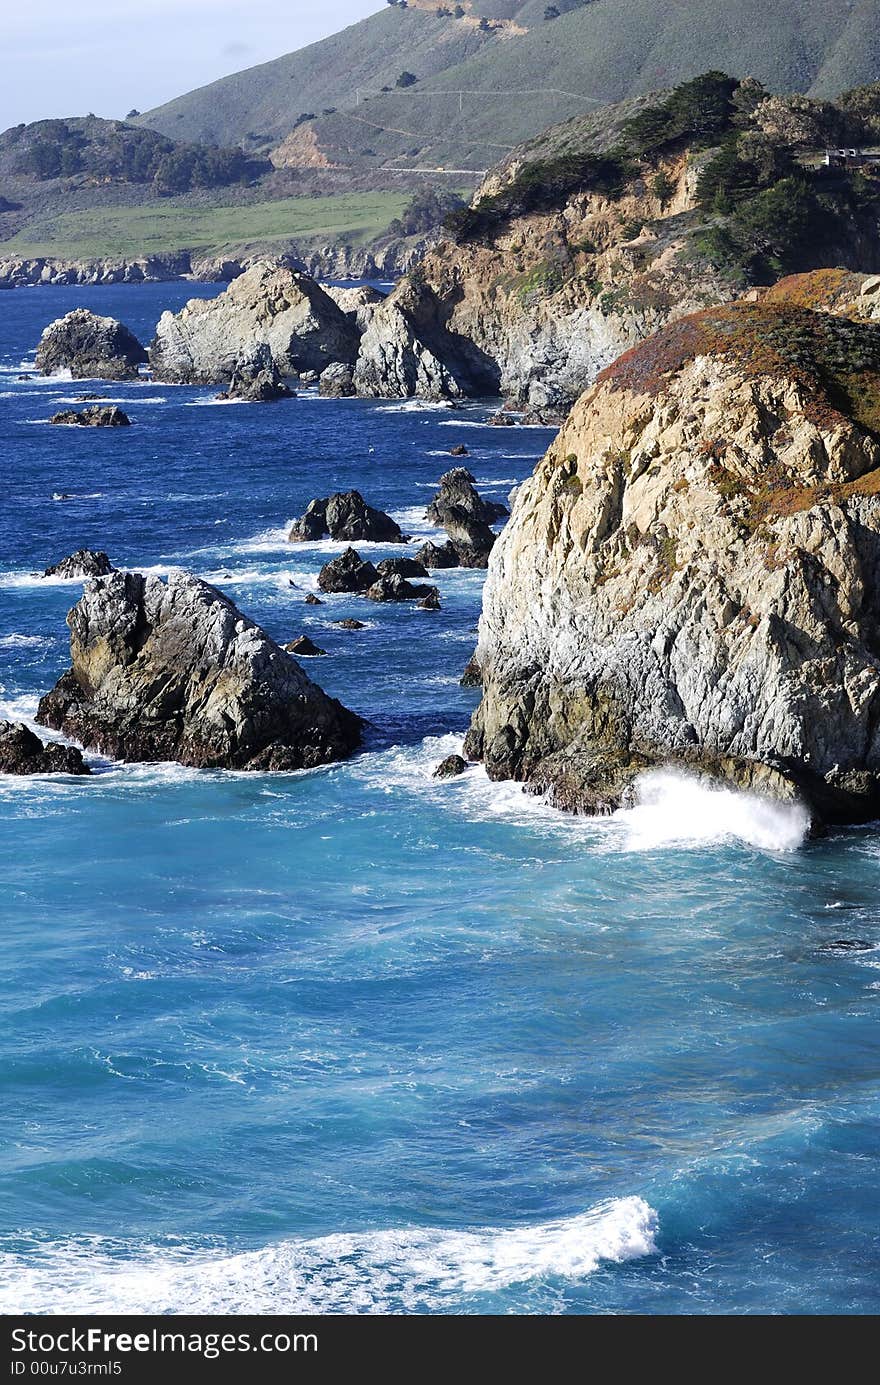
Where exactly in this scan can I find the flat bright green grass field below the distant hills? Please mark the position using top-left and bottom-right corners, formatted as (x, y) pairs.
(0, 193), (412, 259)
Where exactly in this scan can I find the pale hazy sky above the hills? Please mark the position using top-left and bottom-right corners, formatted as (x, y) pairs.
(0, 0), (382, 130)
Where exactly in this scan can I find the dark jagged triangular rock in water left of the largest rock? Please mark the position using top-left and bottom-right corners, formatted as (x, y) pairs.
(37, 572), (362, 770)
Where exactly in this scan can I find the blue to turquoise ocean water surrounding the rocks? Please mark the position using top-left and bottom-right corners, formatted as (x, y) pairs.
(0, 284), (880, 1313)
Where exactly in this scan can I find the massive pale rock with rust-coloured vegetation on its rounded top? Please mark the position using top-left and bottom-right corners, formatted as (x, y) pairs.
(467, 303), (880, 821)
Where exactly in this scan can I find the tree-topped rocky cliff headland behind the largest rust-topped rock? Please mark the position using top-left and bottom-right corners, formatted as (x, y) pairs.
(355, 73), (880, 411)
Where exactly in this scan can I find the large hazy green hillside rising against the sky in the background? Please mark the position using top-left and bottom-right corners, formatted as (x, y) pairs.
(141, 0), (880, 170)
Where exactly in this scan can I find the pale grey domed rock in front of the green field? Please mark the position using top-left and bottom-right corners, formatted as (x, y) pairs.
(150, 260), (359, 385)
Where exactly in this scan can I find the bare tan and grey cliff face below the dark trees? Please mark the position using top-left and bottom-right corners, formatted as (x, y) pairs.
(374, 155), (736, 410)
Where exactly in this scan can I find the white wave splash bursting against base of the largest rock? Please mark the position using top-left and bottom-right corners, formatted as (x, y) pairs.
(614, 770), (809, 852)
